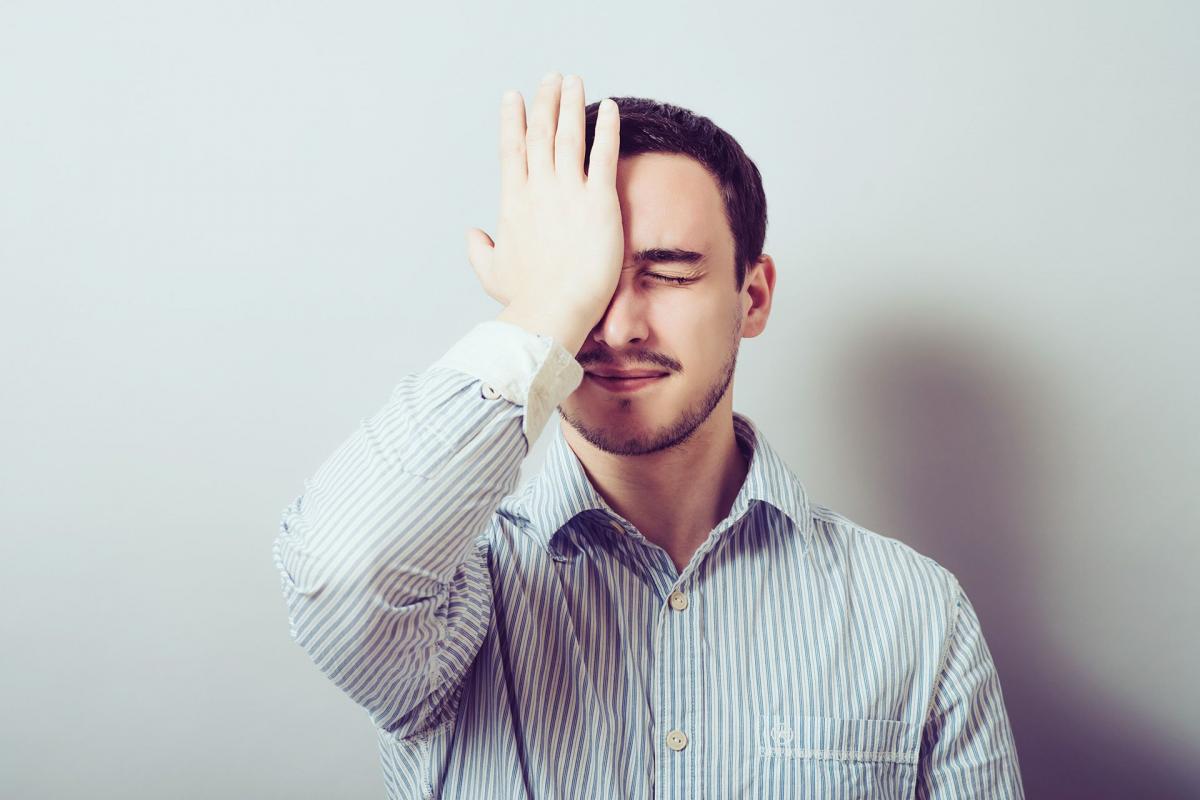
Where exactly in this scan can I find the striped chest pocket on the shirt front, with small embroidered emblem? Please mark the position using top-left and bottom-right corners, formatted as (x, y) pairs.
(752, 714), (920, 800)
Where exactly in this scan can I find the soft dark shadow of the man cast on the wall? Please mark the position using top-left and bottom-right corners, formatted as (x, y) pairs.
(830, 316), (1200, 800)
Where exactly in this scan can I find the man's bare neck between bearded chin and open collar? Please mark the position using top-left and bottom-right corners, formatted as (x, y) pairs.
(559, 404), (749, 572)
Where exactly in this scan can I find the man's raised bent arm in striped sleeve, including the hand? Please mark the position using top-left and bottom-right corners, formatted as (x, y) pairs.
(274, 73), (624, 735)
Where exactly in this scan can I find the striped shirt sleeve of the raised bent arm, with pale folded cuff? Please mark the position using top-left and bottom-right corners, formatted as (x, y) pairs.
(272, 320), (582, 736)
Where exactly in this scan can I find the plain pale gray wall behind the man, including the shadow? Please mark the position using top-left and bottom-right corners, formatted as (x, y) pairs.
(0, 0), (1200, 799)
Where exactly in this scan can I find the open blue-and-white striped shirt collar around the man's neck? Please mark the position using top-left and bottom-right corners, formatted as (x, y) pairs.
(524, 411), (812, 559)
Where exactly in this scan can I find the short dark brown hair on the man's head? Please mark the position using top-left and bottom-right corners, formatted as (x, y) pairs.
(583, 97), (767, 291)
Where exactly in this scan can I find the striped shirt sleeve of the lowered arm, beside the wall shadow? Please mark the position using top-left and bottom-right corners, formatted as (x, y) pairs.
(917, 587), (1025, 800)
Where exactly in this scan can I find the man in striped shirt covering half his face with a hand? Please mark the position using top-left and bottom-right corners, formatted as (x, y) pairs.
(275, 73), (1024, 799)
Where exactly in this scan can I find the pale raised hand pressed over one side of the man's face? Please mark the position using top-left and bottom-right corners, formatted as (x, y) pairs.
(467, 72), (625, 349)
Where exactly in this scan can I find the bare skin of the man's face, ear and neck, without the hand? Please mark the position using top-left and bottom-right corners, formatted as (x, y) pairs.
(559, 152), (775, 571)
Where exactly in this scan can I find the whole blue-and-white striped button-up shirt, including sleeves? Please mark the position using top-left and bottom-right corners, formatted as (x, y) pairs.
(274, 320), (1024, 800)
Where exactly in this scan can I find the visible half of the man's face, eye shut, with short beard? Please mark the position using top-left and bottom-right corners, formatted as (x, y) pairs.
(559, 152), (743, 456)
